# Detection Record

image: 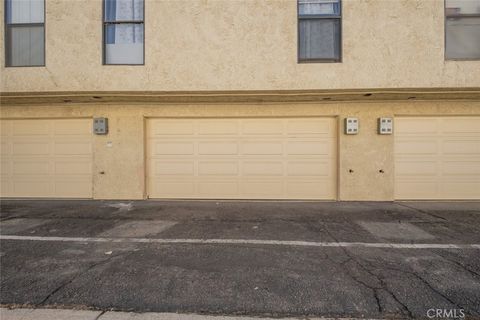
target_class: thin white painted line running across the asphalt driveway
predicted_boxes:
[0,235,480,249]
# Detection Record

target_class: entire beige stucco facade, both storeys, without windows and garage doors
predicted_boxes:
[0,0,480,201]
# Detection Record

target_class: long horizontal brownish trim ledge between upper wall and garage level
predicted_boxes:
[0,87,480,105]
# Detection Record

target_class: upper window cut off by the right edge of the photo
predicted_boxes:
[445,0,480,60]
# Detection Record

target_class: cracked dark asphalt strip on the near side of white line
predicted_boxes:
[2,241,480,317]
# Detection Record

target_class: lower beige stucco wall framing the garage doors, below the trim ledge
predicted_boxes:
[0,101,480,200]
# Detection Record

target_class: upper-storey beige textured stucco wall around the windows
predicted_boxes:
[0,0,480,92]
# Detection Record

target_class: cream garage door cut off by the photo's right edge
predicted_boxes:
[395,117,480,199]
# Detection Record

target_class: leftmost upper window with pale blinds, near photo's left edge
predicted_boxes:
[5,0,45,67]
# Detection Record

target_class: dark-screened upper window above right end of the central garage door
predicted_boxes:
[298,0,341,62]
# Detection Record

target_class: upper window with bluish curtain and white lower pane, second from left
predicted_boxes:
[103,0,144,64]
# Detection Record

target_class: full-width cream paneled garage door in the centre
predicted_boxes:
[147,118,336,199]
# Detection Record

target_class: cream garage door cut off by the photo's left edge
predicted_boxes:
[1,119,92,198]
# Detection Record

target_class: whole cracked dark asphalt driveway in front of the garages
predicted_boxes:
[0,200,480,318]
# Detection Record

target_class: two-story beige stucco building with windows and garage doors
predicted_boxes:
[0,0,480,201]
